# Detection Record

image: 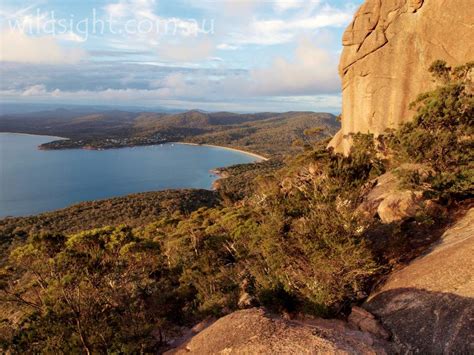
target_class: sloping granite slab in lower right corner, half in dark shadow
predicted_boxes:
[364,209,474,354]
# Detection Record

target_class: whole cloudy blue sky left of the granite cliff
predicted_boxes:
[0,0,362,112]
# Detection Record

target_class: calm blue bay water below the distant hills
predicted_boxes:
[0,133,262,218]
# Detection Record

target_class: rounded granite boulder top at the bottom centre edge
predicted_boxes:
[167,308,391,355]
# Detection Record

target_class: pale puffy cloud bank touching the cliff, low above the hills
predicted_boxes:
[141,38,340,101]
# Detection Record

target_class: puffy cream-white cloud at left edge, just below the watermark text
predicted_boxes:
[0,31,86,64]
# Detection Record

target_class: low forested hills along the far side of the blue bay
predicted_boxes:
[0,109,340,155]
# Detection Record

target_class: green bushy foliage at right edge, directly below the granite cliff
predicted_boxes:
[385,61,474,198]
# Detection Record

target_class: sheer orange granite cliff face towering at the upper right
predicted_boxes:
[330,0,474,153]
